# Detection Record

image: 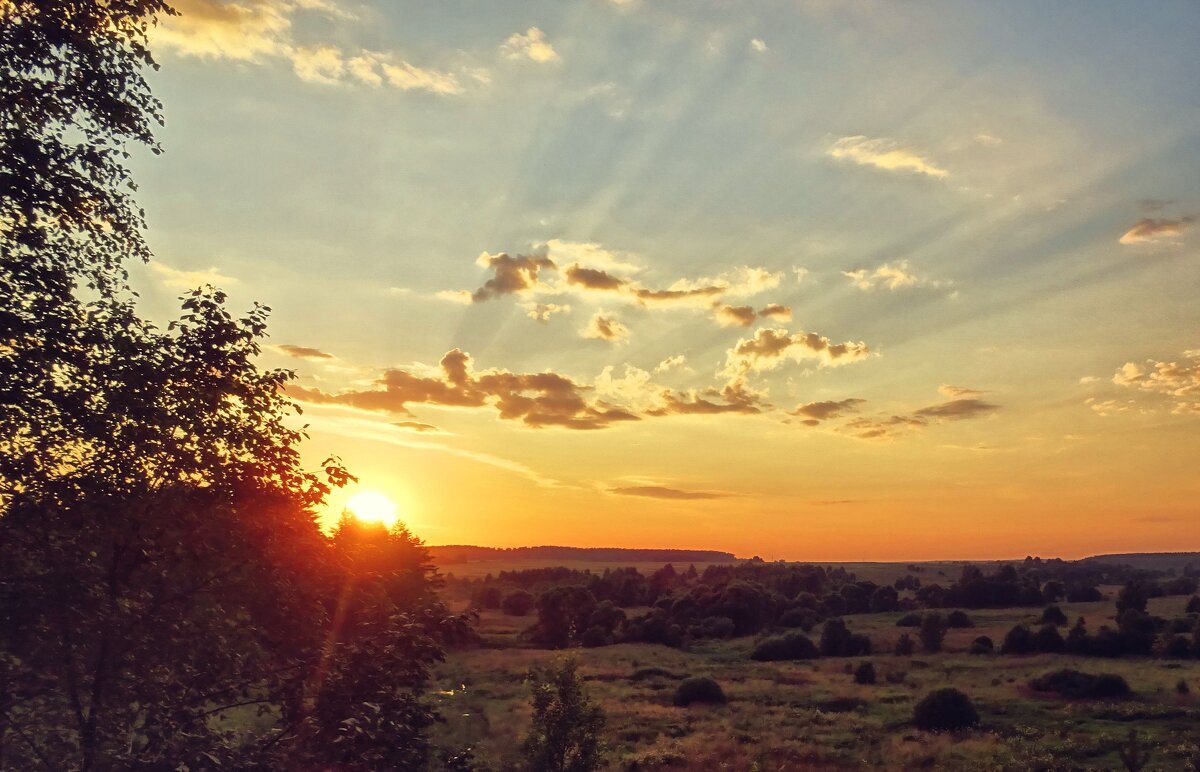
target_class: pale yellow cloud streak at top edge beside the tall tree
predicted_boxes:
[152,0,464,95]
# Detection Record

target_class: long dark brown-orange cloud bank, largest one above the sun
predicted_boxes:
[287,348,638,430]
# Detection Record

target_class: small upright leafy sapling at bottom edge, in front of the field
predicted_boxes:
[521,658,605,772]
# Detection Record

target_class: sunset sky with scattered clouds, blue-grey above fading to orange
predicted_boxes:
[126,0,1200,561]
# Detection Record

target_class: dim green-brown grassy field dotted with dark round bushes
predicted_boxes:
[437,598,1200,770]
